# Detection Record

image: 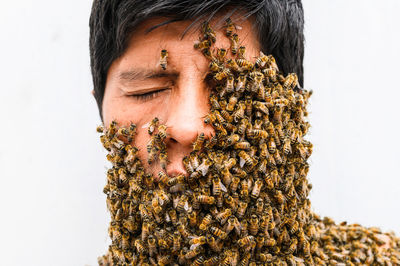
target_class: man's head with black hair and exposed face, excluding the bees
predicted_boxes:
[90,0,303,179]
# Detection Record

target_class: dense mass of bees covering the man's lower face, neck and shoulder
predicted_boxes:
[98,20,400,265]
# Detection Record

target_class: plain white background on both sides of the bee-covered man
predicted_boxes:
[0,0,400,265]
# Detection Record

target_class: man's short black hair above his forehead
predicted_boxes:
[89,0,304,118]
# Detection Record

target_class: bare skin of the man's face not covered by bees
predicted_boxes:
[103,18,260,179]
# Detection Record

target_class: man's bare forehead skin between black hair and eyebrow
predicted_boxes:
[117,15,260,64]
